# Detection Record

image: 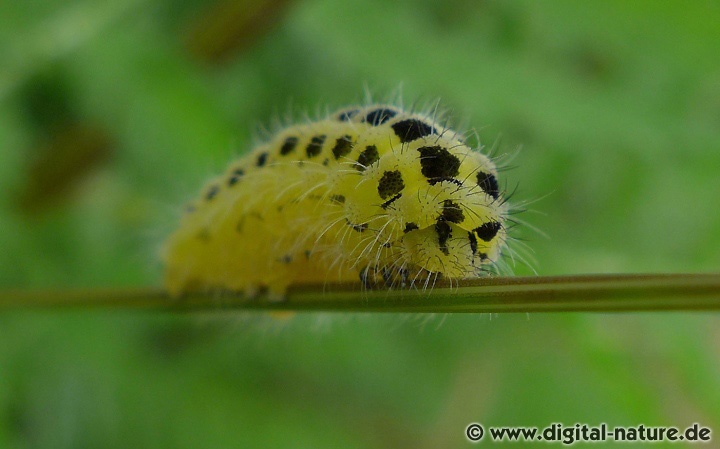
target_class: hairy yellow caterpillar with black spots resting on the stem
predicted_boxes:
[162,104,509,297]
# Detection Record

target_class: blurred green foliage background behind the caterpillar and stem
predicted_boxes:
[0,0,720,448]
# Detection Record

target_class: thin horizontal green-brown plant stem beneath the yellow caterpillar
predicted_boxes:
[0,274,720,313]
